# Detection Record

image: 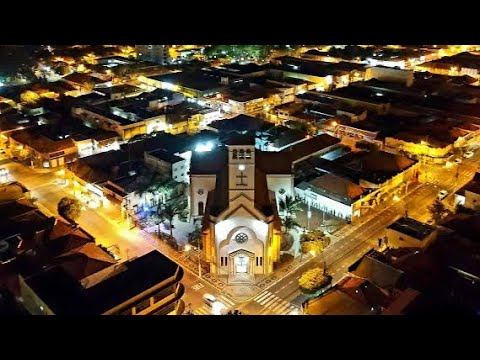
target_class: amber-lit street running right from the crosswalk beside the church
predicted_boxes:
[239,152,480,315]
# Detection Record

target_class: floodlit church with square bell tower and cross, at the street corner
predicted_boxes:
[190,135,337,282]
